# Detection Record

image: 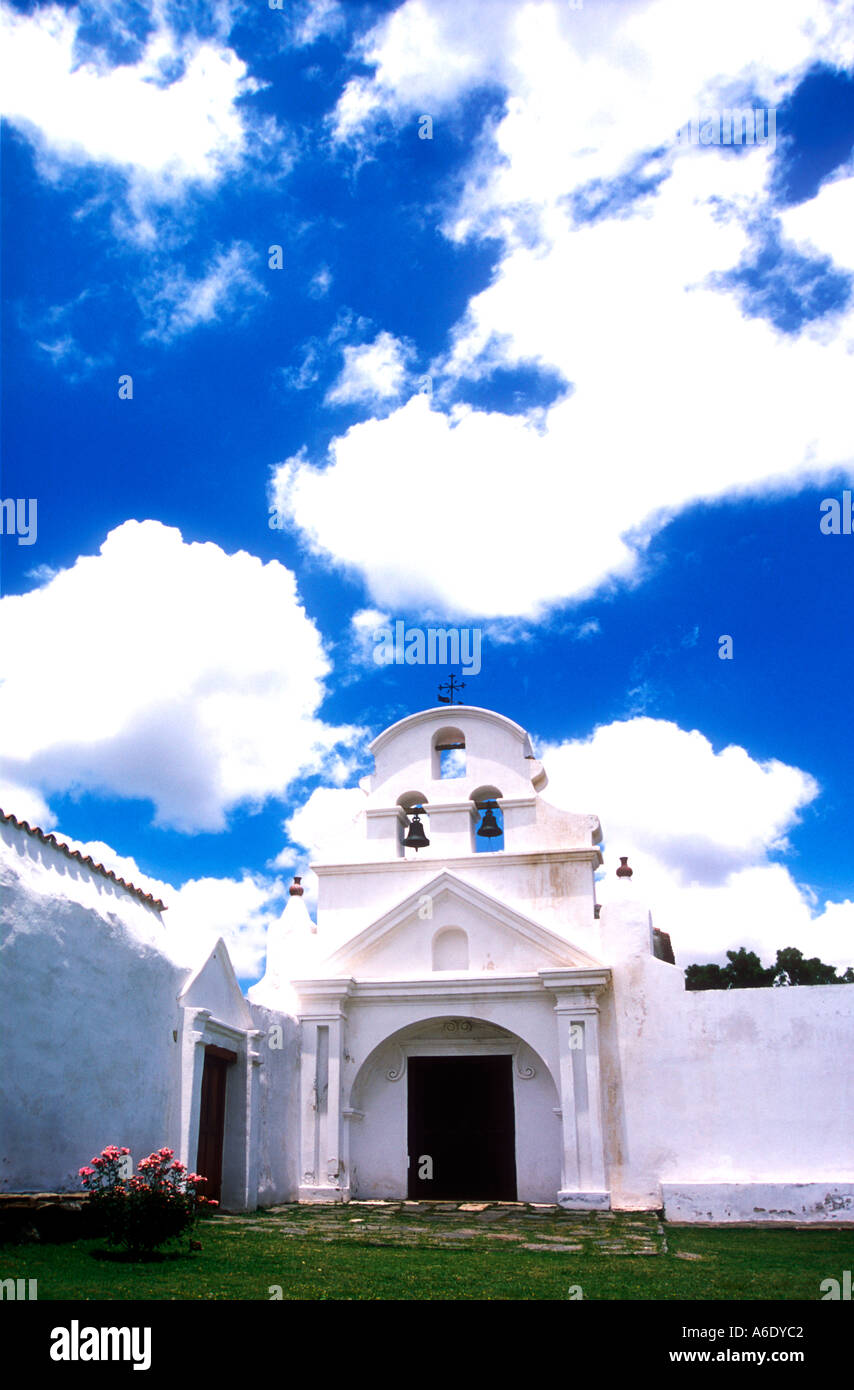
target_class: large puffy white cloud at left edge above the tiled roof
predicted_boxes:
[0,521,357,831]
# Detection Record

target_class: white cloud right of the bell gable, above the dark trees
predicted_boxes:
[541,719,854,969]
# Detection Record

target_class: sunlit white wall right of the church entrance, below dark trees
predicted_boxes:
[602,904,854,1220]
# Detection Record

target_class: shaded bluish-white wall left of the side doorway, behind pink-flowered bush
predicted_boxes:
[0,824,186,1191]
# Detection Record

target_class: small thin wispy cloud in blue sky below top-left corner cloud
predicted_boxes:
[139,242,267,342]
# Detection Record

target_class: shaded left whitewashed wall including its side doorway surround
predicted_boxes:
[0,824,299,1209]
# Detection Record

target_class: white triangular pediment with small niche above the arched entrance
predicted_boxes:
[319,869,599,980]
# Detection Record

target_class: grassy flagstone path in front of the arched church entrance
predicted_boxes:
[214,1201,668,1255]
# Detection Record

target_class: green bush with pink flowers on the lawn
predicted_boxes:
[79,1144,217,1255]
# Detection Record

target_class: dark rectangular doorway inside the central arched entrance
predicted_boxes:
[408,1056,516,1201]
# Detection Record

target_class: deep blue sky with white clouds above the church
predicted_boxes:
[0,0,854,980]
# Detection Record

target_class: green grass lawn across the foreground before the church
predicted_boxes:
[0,1218,854,1301]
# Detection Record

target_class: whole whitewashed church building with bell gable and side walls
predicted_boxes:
[0,706,854,1222]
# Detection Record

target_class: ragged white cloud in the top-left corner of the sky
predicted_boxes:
[0,3,287,247]
